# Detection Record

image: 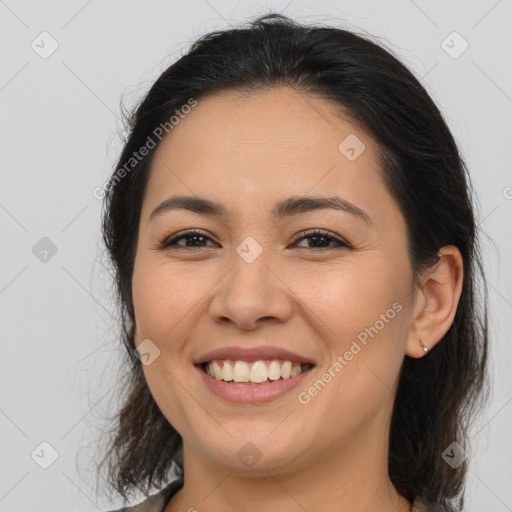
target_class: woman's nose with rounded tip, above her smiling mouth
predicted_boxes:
[210,255,293,330]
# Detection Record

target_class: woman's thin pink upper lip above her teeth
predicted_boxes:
[194,346,316,366]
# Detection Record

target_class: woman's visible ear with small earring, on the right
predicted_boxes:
[405,245,463,358]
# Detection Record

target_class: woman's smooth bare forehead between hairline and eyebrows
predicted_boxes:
[146,88,391,224]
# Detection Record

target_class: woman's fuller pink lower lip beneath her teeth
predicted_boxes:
[196,366,313,404]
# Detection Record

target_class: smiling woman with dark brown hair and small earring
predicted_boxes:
[100,15,487,512]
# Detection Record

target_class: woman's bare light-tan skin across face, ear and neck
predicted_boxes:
[133,88,462,512]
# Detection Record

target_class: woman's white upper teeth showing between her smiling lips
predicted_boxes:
[206,359,308,383]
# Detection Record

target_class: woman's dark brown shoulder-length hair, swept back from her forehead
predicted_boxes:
[99,14,488,510]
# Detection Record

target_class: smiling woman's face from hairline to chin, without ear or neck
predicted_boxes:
[132,88,412,474]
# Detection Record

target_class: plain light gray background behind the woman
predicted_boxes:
[0,0,512,512]
